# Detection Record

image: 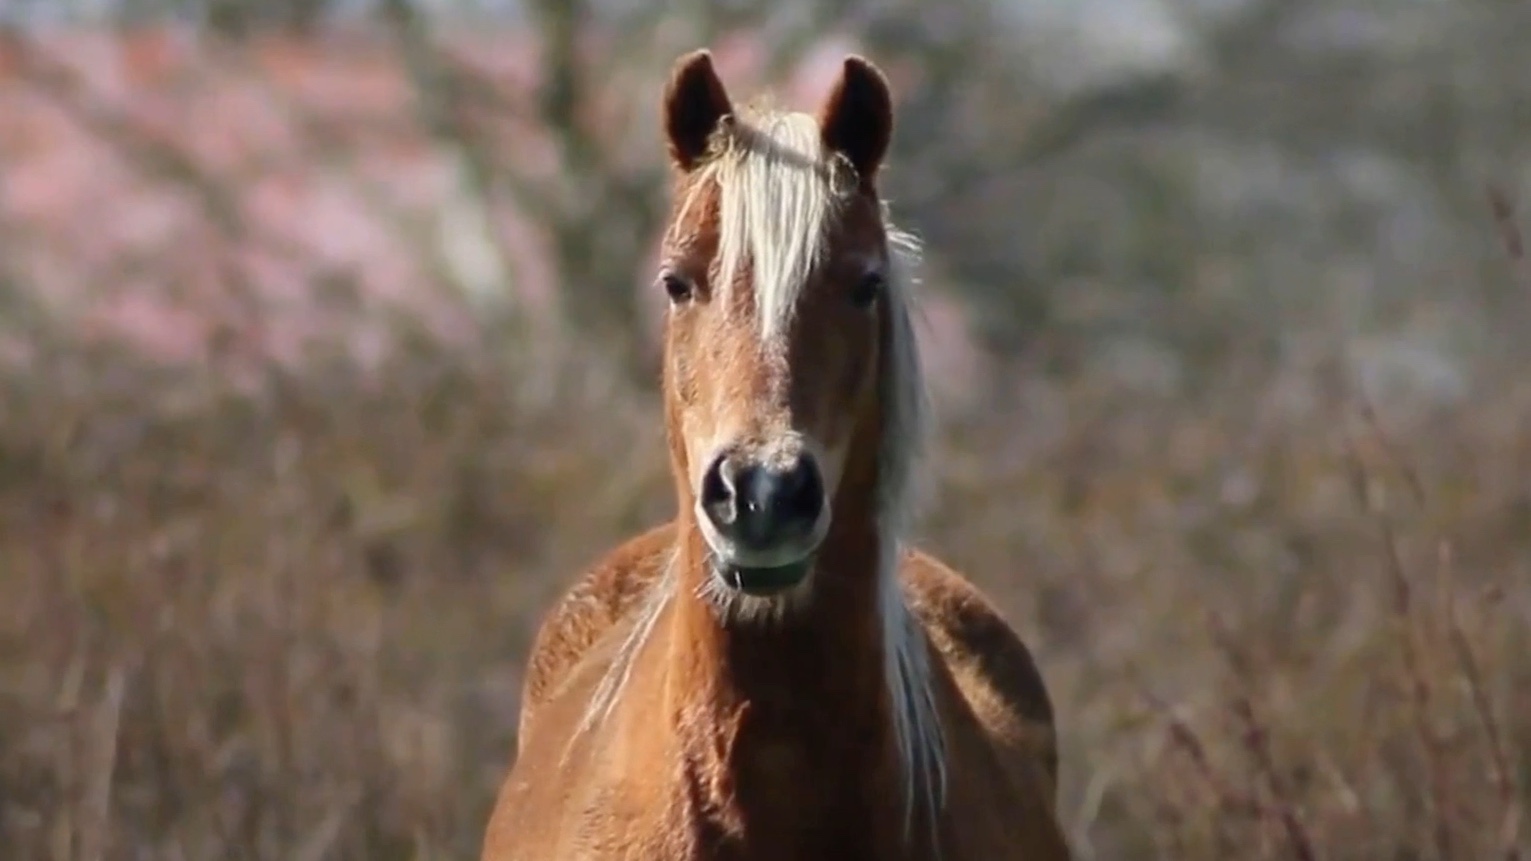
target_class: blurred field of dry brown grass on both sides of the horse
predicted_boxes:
[0,317,1531,861]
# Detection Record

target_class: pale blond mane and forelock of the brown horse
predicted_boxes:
[574,103,946,830]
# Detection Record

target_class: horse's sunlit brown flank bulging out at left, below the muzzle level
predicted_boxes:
[517,514,675,740]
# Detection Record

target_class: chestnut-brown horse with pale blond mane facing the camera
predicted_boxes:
[482,51,1069,861]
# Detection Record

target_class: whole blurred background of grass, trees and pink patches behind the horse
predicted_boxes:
[0,0,1531,861]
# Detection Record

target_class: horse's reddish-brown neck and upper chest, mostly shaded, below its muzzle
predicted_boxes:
[666,464,903,850]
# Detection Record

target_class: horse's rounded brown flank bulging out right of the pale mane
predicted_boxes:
[900,550,1058,794]
